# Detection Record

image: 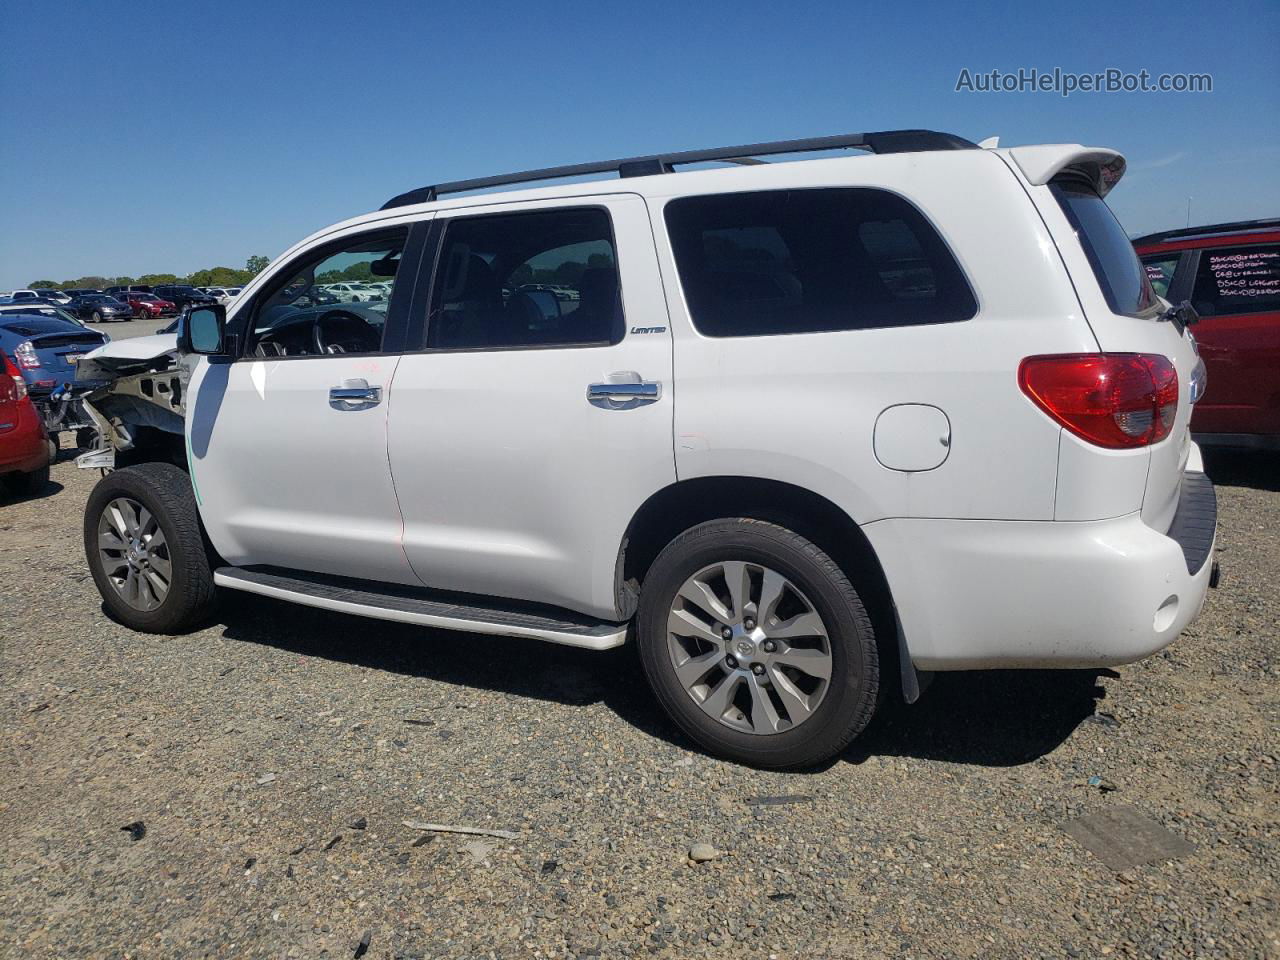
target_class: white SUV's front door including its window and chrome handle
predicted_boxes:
[187,224,426,584]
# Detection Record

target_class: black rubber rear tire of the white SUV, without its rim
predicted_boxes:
[637,518,879,769]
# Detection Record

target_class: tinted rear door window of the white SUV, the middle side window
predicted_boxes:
[426,207,623,349]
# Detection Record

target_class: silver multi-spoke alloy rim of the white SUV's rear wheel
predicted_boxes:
[667,561,832,736]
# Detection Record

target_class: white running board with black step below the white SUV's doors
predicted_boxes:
[214,567,627,650]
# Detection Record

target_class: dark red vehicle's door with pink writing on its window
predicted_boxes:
[1190,242,1280,435]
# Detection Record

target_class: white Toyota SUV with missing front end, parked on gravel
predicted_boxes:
[74,131,1216,768]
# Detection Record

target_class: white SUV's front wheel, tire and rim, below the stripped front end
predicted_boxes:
[84,463,215,634]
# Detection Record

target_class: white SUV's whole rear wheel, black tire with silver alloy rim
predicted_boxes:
[637,518,879,769]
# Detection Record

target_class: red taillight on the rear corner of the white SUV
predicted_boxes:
[1018,353,1178,449]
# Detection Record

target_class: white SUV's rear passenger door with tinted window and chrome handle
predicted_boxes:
[390,195,676,618]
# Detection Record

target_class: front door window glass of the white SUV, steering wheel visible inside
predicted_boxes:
[246,229,408,358]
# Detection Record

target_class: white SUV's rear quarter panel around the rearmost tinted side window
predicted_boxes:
[649,150,1097,524]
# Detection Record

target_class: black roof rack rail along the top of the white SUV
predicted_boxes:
[381,131,978,210]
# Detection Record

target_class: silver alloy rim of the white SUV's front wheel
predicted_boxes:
[97,497,173,611]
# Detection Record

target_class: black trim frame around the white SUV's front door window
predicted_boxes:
[228,219,431,364]
